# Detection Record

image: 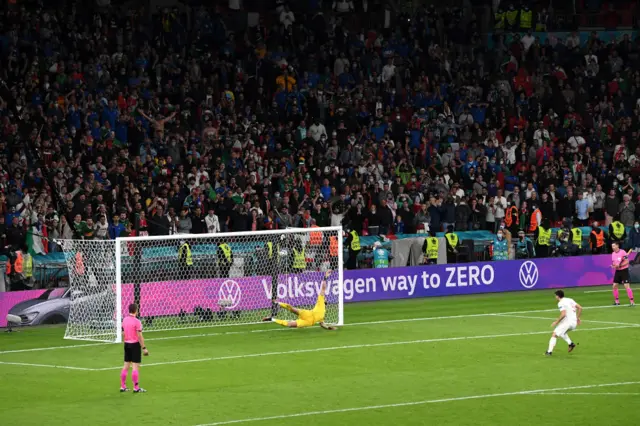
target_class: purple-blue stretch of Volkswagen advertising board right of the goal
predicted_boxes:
[344,255,613,302]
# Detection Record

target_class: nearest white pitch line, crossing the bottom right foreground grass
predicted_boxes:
[198,382,640,426]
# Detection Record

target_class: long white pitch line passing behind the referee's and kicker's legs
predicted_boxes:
[93,325,637,371]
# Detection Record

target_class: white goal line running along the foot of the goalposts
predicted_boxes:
[0,305,614,355]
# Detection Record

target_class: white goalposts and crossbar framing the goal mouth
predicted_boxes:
[102,226,344,343]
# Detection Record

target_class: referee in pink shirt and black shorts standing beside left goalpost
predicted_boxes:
[120,303,149,393]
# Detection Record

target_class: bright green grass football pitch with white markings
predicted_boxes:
[0,286,640,426]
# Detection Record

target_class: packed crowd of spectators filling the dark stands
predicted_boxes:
[0,0,640,272]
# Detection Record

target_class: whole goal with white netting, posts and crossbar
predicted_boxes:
[62,227,344,342]
